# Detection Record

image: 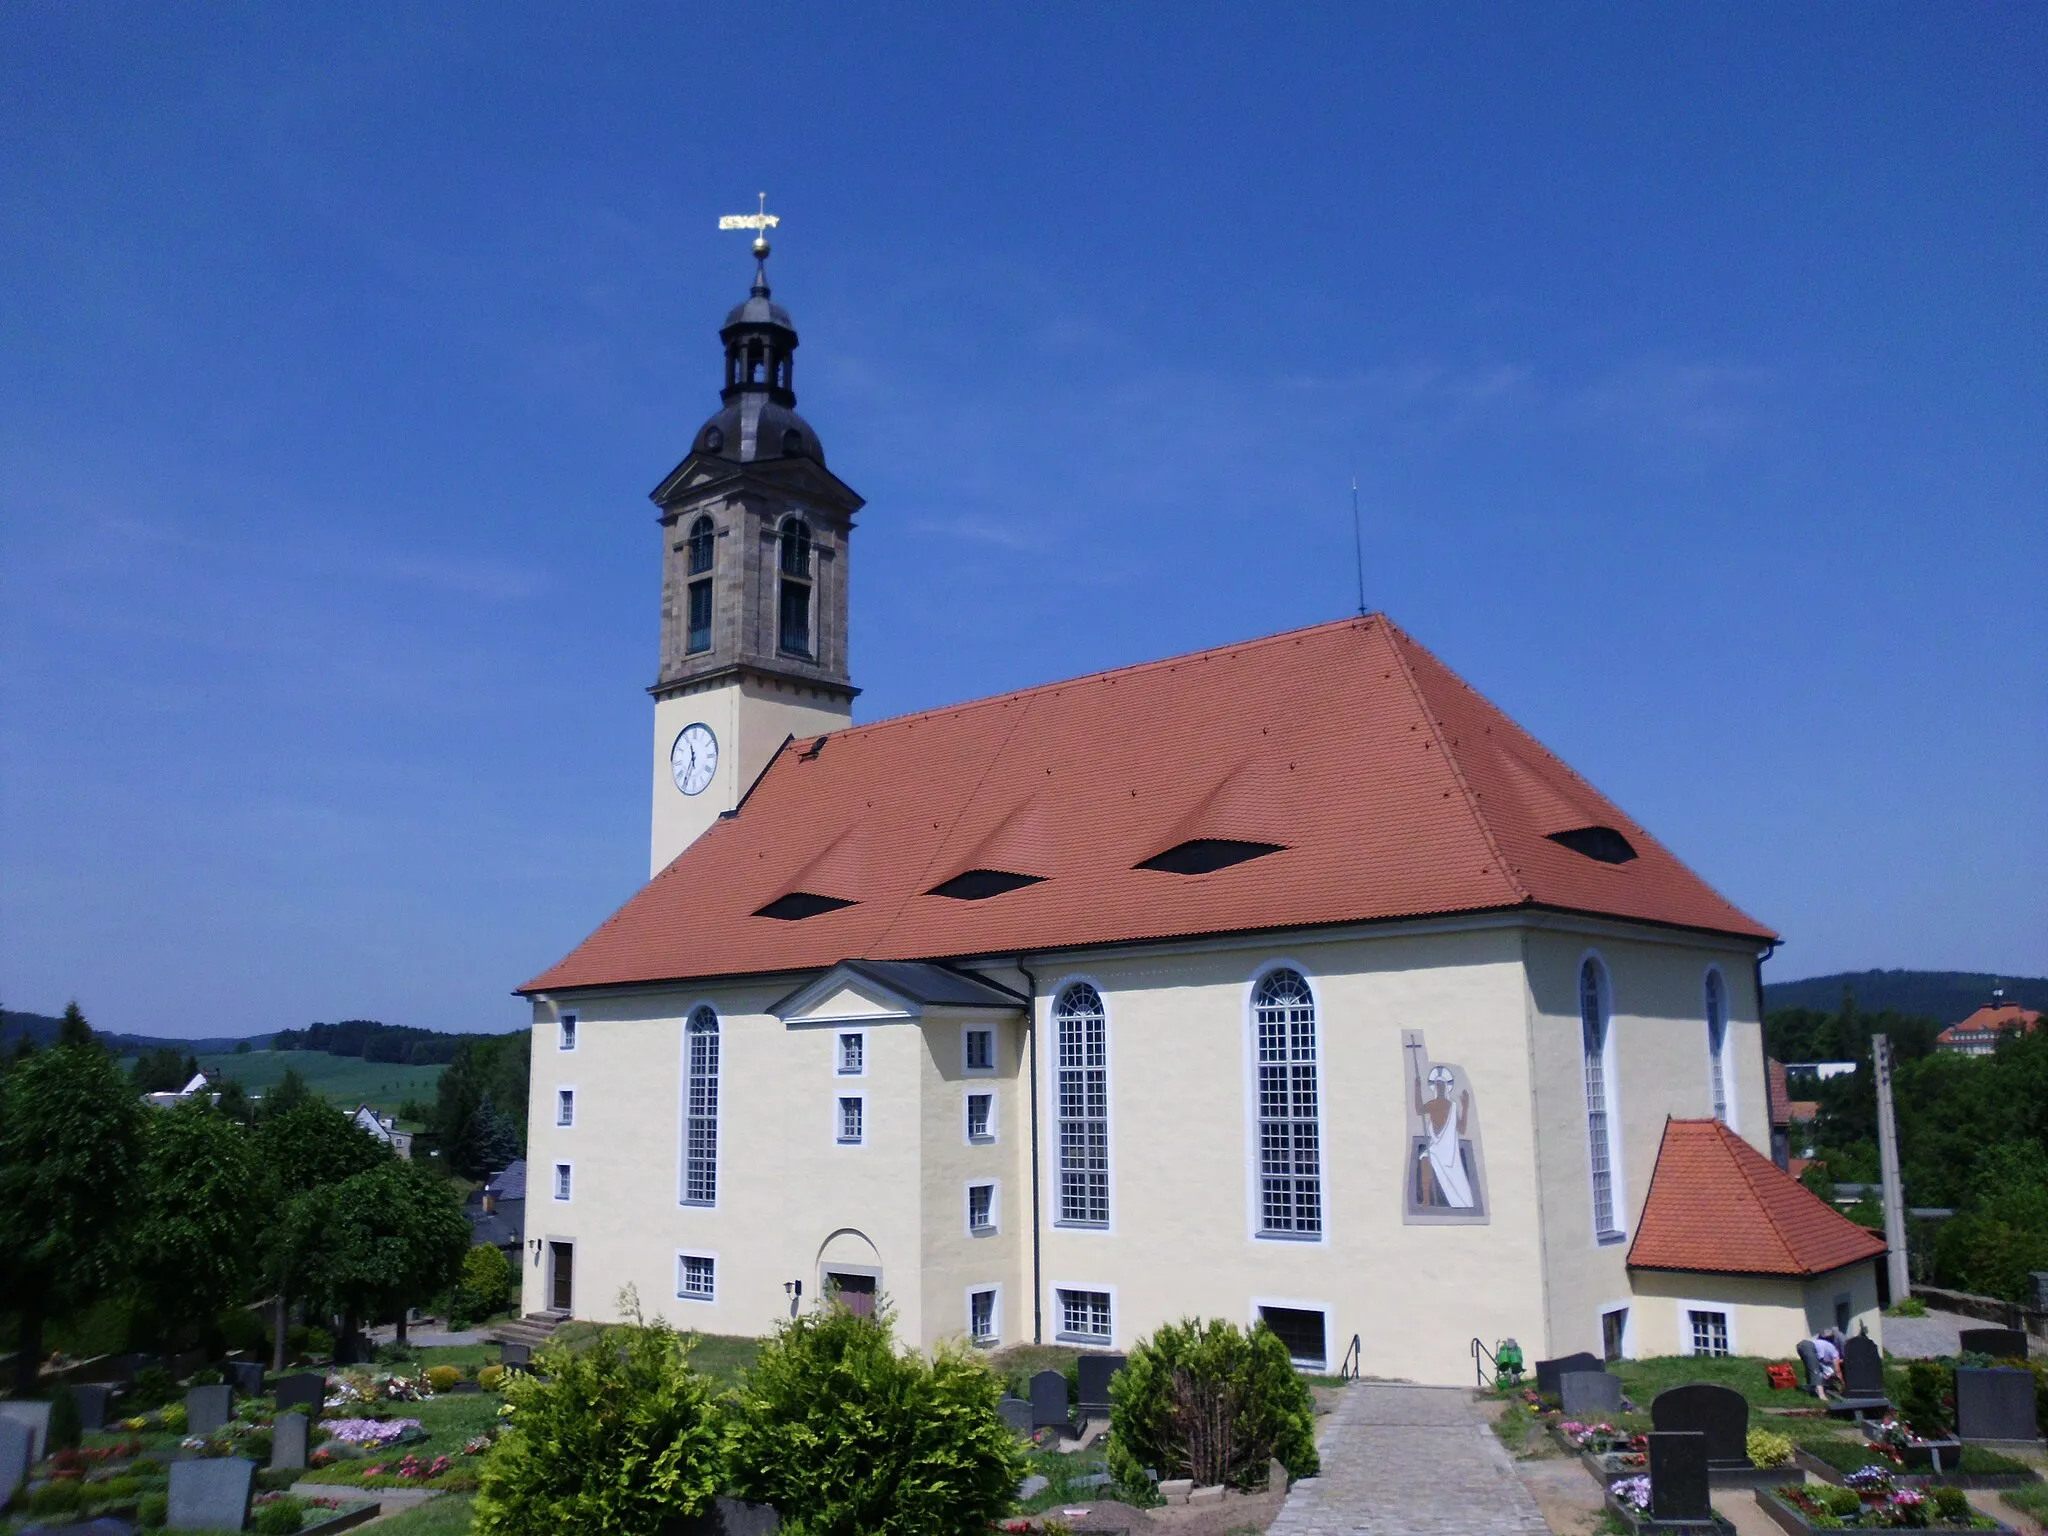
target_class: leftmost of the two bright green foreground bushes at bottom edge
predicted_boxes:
[475,1323,725,1536]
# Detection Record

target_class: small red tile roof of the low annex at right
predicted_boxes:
[1628,1120,1884,1276]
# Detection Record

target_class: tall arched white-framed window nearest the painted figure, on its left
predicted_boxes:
[1251,971,1323,1237]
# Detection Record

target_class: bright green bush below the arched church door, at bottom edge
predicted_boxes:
[729,1303,1024,1536]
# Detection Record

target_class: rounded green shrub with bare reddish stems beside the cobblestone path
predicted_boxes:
[1110,1319,1319,1491]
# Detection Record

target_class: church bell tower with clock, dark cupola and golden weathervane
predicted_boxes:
[647,211,862,877]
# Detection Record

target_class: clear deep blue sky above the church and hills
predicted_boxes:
[0,0,2048,1034]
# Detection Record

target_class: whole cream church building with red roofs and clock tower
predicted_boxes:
[520,240,1882,1382]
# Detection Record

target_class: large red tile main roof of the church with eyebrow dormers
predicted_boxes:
[522,614,1774,991]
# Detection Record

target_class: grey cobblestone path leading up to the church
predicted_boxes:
[1268,1382,1550,1536]
